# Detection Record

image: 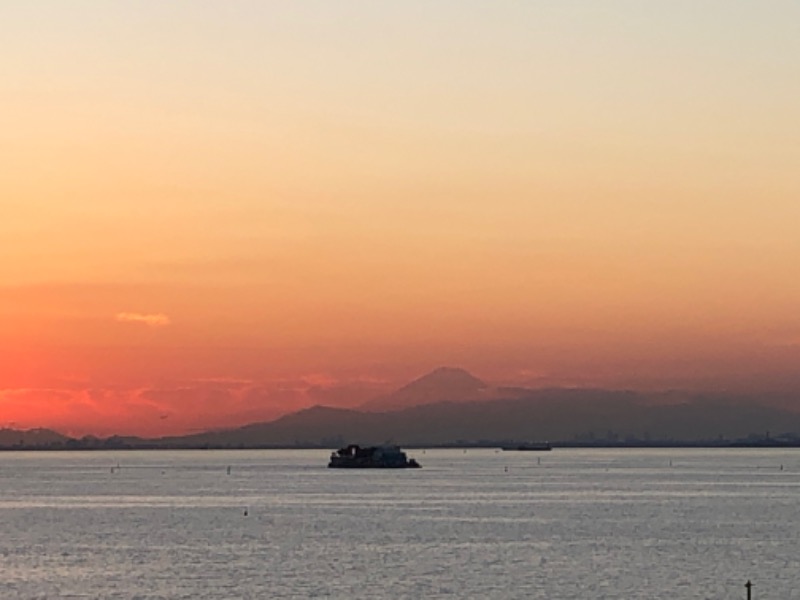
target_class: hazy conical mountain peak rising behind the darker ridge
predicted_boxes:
[359,367,493,412]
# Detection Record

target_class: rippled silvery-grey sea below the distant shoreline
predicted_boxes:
[0,448,800,600]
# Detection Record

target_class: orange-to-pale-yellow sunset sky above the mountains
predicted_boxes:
[0,0,800,435]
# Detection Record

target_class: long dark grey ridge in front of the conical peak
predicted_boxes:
[161,389,800,447]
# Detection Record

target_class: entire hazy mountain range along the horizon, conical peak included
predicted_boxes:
[6,368,800,449]
